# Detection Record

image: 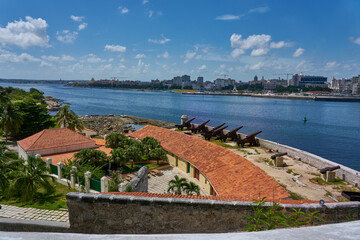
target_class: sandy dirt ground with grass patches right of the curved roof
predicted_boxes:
[190,135,360,202]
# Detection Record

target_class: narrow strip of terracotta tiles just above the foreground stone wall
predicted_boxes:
[104,192,317,204]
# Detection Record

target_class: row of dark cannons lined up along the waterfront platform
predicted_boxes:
[176,115,262,147]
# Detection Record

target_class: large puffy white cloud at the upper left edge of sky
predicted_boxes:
[0,16,50,48]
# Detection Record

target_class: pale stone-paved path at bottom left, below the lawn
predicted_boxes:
[0,204,69,222]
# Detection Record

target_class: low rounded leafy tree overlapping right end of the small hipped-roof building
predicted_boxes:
[74,148,108,167]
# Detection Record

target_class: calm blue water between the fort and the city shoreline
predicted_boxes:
[0,82,360,170]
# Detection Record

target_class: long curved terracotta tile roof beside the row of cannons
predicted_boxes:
[128,125,290,201]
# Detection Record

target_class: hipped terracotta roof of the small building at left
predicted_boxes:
[17,128,94,151]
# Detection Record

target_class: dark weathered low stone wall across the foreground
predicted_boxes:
[66,193,360,234]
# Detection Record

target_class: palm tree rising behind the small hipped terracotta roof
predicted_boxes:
[55,104,84,131]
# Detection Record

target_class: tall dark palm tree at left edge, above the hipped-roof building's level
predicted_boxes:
[0,99,23,142]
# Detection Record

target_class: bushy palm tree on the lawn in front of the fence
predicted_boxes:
[9,157,54,201]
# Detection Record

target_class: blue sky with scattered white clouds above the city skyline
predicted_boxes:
[0,0,360,81]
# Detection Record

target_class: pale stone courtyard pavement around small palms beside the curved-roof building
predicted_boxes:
[148,167,208,196]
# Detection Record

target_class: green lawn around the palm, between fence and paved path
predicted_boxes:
[0,182,75,210]
